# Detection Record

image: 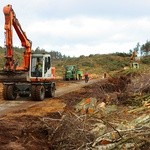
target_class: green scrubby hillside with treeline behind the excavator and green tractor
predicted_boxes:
[0,47,150,76]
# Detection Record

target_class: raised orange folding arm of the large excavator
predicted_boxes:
[3,5,32,71]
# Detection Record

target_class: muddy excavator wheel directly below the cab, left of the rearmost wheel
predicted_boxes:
[36,85,45,101]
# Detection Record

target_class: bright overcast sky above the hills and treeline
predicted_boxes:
[0,0,150,56]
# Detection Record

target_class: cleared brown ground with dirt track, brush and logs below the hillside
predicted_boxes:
[0,74,150,150]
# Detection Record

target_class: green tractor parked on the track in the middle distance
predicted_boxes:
[64,65,83,80]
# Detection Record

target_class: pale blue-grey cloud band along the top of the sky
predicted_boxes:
[28,0,150,18]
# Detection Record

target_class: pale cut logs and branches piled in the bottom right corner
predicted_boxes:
[92,114,150,150]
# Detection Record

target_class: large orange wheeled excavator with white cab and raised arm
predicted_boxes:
[0,4,56,101]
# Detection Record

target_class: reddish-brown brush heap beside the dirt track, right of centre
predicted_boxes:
[83,76,131,104]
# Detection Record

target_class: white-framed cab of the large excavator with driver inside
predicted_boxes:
[29,54,55,80]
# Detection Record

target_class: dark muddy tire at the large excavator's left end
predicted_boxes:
[7,85,17,100]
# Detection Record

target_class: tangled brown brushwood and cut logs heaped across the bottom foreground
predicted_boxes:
[20,112,150,150]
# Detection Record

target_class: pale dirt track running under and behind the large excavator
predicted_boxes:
[0,79,100,117]
